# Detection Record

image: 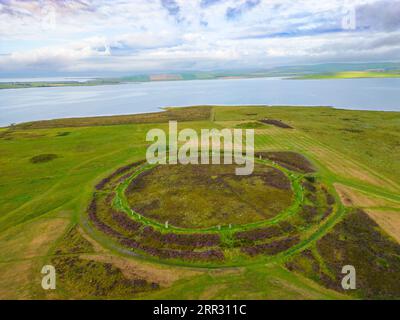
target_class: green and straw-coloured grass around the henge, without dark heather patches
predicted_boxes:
[0,106,400,299]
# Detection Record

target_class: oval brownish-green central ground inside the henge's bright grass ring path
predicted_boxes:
[126,164,293,228]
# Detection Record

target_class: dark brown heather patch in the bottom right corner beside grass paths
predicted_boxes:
[286,210,400,299]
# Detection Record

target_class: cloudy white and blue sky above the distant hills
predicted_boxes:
[0,0,400,77]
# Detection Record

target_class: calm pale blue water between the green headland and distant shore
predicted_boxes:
[0,77,400,127]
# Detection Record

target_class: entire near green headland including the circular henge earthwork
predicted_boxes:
[0,106,400,299]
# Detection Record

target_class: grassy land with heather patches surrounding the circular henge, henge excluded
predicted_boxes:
[0,106,400,299]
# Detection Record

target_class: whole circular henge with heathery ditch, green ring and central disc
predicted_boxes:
[88,156,336,267]
